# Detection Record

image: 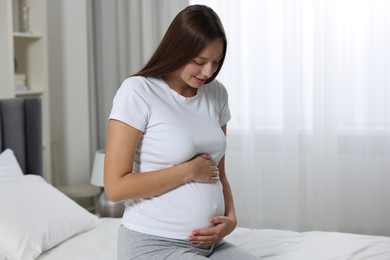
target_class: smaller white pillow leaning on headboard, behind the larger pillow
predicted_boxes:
[0,149,23,181]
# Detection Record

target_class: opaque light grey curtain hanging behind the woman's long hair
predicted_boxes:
[89,0,188,150]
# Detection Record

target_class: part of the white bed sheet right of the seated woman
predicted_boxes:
[226,228,390,260]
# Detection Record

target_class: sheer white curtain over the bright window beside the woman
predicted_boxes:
[190,0,390,235]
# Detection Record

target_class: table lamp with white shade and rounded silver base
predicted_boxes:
[91,150,125,218]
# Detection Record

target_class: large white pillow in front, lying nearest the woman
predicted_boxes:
[0,175,100,260]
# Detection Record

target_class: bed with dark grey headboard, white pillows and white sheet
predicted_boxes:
[0,99,390,260]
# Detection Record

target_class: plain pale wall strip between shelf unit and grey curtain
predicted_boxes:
[47,0,91,185]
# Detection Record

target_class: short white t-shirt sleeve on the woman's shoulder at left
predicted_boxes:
[109,77,150,132]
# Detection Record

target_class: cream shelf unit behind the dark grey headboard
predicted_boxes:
[0,0,51,181]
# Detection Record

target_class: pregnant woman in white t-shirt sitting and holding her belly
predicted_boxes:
[104,5,257,260]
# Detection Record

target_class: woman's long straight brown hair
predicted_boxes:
[134,5,227,83]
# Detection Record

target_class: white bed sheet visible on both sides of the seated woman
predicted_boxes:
[38,218,390,260]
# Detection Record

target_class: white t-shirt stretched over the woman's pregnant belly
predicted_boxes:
[110,76,230,239]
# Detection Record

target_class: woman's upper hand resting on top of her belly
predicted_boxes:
[188,154,219,182]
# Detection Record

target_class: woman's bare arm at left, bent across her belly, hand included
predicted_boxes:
[104,119,218,201]
